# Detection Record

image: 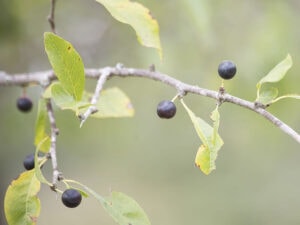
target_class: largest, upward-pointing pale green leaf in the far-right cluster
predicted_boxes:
[256,54,293,95]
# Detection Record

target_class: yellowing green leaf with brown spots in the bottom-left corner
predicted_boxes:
[4,170,40,225]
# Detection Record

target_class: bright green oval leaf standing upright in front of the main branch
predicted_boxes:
[44,32,85,101]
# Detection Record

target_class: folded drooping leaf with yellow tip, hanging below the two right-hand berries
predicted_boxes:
[180,99,224,175]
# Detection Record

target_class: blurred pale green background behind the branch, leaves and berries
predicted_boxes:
[0,0,300,225]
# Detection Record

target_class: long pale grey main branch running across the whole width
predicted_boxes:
[0,66,300,143]
